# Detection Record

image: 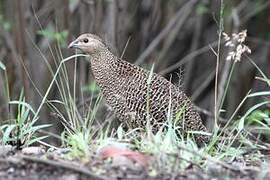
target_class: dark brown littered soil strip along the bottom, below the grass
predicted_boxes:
[0,146,270,180]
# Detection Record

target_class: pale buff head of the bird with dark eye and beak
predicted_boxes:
[68,34,107,54]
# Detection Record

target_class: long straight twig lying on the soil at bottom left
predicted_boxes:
[20,155,108,180]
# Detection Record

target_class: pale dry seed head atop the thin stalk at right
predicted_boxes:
[222,30,251,62]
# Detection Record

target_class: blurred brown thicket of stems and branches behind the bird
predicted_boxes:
[0,0,270,136]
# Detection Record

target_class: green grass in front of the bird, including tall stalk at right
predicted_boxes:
[0,1,270,179]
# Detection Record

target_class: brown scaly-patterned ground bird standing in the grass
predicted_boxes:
[68,33,209,143]
